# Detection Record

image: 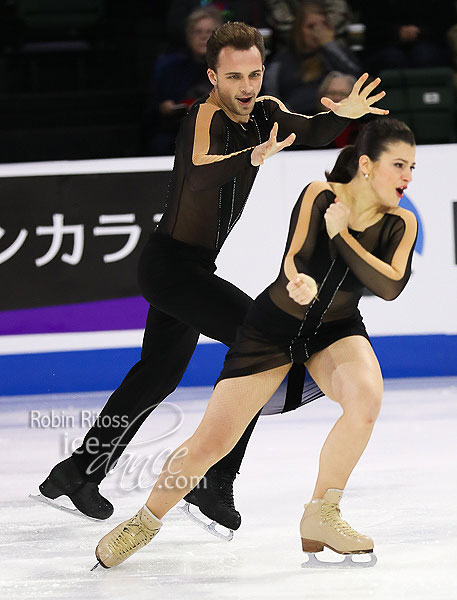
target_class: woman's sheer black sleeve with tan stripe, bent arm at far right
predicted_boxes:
[333,208,417,300]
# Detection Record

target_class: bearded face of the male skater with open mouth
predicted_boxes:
[208,46,264,122]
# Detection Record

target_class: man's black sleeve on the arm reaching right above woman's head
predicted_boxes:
[259,96,351,148]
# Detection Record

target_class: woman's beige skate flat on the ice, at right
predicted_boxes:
[300,489,377,568]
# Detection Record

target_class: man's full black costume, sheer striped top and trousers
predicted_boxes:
[68,92,348,482]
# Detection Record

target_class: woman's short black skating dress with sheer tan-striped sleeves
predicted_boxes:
[218,182,417,398]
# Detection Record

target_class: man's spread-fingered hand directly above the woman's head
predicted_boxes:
[321,73,389,119]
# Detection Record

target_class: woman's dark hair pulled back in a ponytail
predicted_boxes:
[325,117,416,183]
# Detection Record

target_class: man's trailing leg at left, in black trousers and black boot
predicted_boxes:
[40,307,199,519]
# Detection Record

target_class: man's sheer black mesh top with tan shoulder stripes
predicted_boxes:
[157,92,348,253]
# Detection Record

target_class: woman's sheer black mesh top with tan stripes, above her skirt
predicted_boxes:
[268,181,417,321]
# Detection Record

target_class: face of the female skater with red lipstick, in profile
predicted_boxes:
[368,142,416,208]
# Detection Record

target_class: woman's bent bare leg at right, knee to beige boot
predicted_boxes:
[306,336,383,499]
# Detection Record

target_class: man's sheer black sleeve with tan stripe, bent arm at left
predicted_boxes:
[182,103,258,192]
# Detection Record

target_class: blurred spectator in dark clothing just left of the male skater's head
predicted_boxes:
[146,7,222,156]
